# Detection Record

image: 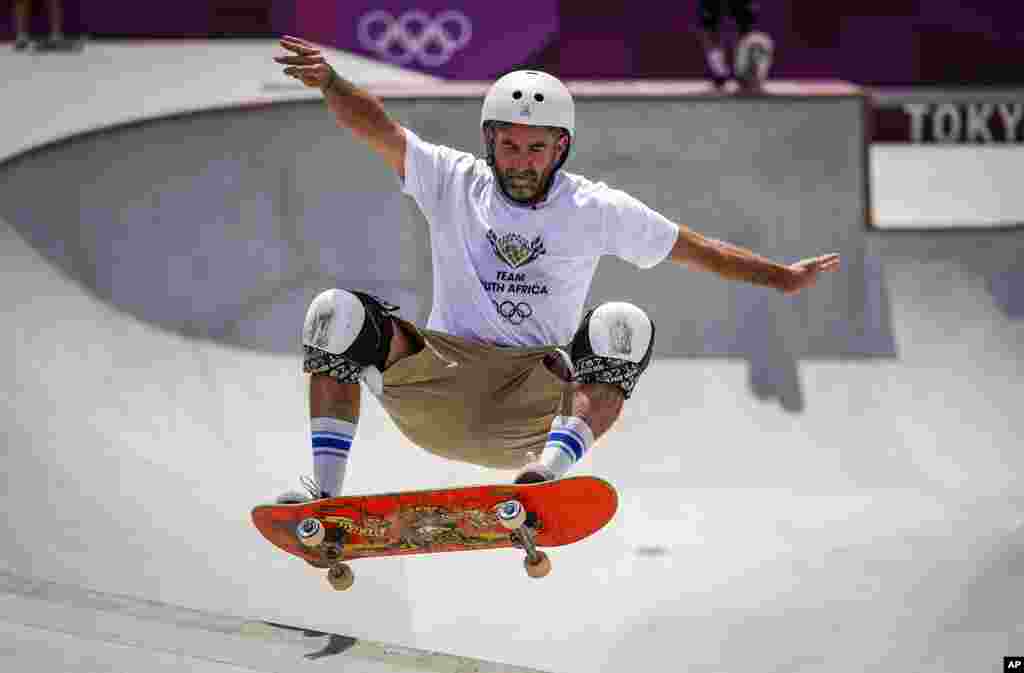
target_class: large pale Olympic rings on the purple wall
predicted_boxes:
[358,9,473,68]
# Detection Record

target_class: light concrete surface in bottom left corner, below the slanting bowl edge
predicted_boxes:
[0,574,540,673]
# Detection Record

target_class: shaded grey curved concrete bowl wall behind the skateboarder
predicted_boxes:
[0,87,896,395]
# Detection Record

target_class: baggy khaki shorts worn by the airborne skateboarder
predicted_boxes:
[380,316,571,469]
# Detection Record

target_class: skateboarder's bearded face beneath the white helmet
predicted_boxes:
[494,124,568,203]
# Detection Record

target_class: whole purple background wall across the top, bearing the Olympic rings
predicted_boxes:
[0,0,1024,86]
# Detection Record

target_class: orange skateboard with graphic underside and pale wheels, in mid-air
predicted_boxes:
[252,476,618,590]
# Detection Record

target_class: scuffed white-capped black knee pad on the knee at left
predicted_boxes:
[302,290,398,383]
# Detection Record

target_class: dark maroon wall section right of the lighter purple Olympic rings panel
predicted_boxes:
[520,0,1024,85]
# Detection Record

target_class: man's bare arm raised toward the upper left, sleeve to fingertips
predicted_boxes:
[274,35,406,177]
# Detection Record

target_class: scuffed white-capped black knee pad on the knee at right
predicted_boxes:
[569,302,654,399]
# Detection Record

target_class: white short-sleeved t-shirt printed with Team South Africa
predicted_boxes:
[402,129,679,346]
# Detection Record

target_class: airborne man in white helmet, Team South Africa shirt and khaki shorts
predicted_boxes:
[274,37,839,502]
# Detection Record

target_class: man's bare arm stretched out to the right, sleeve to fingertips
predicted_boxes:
[669,224,840,294]
